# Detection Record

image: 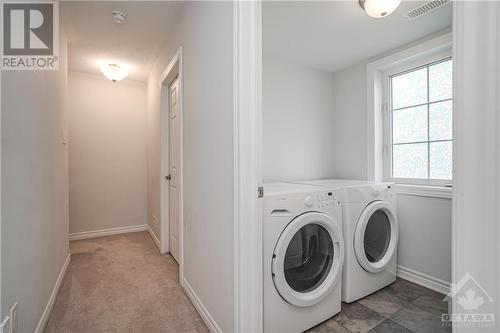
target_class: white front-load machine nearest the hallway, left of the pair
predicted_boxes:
[263,183,344,333]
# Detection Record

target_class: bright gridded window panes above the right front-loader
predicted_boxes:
[385,58,453,185]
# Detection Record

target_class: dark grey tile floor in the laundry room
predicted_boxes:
[308,279,451,333]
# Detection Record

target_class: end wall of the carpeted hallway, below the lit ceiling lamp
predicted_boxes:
[69,71,147,233]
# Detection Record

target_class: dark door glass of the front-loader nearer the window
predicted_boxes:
[363,209,391,262]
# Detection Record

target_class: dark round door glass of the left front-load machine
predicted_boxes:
[284,223,334,293]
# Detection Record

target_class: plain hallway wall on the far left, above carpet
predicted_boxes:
[1,33,69,333]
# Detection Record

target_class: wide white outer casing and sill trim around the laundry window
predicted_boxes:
[366,32,452,198]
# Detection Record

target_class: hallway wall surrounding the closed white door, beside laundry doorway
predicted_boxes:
[148,2,234,332]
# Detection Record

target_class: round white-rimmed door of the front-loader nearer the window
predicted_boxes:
[354,201,399,273]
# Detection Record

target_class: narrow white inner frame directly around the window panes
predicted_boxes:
[382,49,453,187]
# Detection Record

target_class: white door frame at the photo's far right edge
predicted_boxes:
[450,1,500,322]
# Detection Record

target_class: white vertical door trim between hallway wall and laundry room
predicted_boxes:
[233,0,264,332]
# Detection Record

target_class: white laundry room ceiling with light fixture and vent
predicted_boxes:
[262,0,452,72]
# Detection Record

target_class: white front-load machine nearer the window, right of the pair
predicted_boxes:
[290,179,399,303]
